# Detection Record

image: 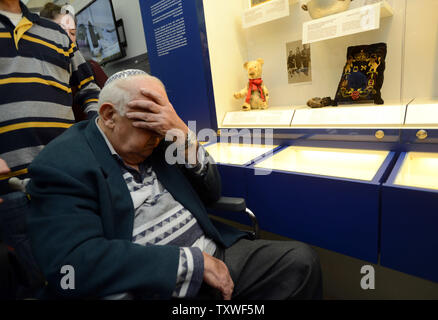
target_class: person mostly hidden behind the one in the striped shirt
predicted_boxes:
[40,2,108,121]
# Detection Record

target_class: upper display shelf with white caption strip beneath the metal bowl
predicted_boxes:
[303,1,394,43]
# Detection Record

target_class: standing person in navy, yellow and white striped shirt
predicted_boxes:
[0,0,100,298]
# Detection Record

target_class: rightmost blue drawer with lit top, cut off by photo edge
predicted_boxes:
[381,151,438,282]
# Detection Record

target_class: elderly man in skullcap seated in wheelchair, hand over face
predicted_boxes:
[28,70,321,299]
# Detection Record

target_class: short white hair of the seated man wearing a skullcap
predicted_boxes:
[98,69,165,116]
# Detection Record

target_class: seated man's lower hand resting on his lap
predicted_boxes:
[202,252,234,300]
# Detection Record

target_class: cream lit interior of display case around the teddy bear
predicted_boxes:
[204,0,408,134]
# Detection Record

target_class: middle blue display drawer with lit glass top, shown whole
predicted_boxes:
[246,146,395,263]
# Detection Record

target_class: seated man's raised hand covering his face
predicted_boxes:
[126,89,188,137]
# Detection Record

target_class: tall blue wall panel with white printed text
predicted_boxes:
[140,0,217,131]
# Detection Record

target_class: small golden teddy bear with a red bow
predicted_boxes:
[234,58,269,111]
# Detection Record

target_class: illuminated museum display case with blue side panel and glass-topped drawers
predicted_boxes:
[140,0,438,281]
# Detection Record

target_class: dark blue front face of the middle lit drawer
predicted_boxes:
[247,170,380,263]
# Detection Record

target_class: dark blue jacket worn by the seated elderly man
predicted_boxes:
[28,119,245,299]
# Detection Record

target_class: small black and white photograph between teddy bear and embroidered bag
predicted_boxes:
[286,40,312,83]
